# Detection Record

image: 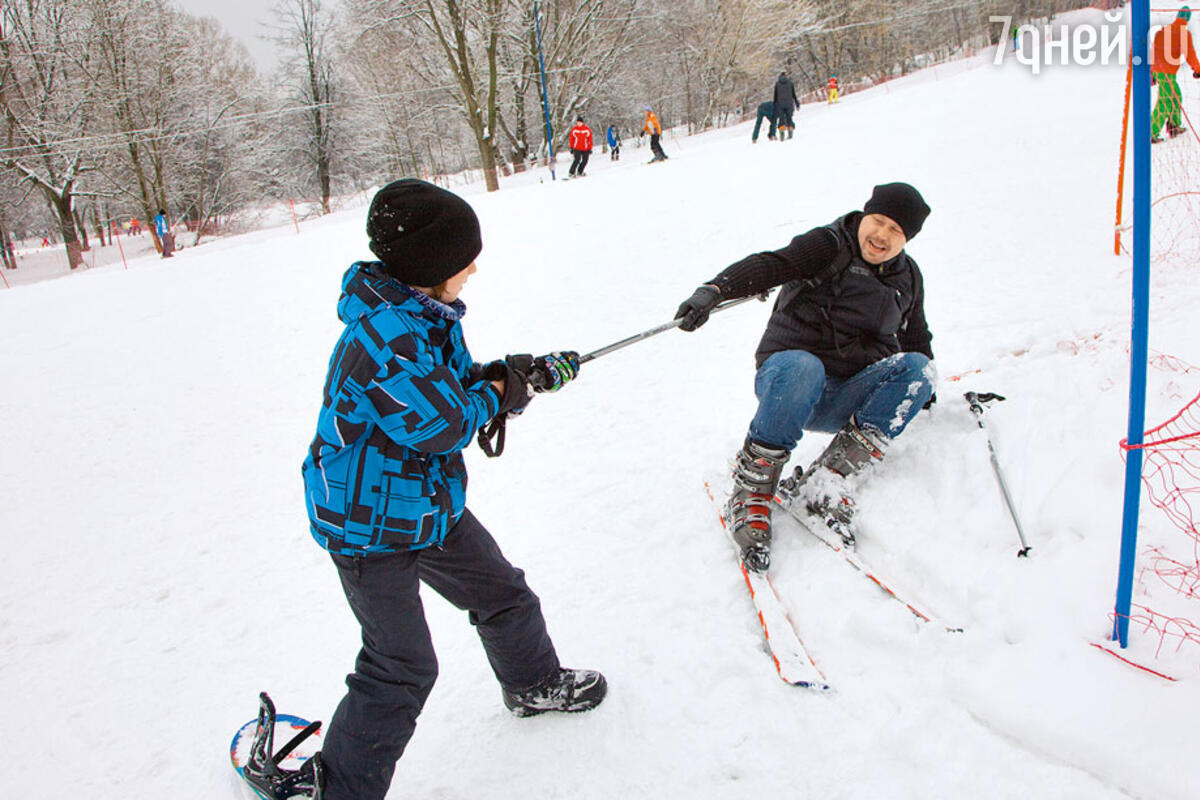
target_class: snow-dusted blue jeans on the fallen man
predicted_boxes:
[750,350,934,451]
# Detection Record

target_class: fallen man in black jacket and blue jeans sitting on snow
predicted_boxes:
[676,184,936,571]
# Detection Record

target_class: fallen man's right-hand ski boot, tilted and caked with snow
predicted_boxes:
[779,417,890,548]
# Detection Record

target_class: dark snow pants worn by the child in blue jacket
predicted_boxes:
[322,510,559,800]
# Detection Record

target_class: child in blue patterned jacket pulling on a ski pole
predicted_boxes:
[301,179,606,800]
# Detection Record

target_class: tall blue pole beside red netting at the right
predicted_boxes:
[1112,0,1150,648]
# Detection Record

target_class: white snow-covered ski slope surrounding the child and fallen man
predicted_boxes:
[0,31,1200,800]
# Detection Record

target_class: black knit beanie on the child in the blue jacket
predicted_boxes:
[367,178,484,287]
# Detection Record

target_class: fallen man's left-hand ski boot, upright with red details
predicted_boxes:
[725,439,791,572]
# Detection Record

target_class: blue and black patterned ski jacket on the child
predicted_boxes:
[302,261,500,555]
